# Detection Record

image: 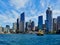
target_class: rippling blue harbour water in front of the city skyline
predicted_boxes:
[0,34,60,45]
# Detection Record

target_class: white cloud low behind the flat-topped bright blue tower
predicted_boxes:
[26,12,46,25]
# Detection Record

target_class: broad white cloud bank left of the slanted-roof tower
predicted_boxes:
[0,10,19,23]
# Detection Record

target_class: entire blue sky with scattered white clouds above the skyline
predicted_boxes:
[0,0,60,27]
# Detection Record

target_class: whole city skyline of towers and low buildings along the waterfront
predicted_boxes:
[0,7,60,34]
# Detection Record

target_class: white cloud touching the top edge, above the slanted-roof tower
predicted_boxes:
[10,0,29,9]
